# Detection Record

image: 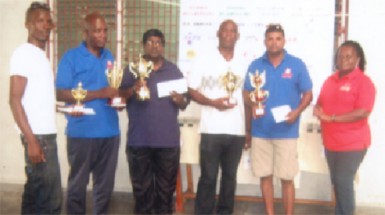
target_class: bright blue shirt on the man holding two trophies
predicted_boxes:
[56,42,120,138]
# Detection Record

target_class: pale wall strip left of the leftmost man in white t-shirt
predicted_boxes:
[0,0,34,183]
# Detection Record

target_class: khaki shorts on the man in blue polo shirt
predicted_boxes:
[251,137,299,180]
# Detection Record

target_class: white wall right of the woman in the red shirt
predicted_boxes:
[348,0,385,207]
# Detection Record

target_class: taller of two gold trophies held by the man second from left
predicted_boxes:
[106,61,126,107]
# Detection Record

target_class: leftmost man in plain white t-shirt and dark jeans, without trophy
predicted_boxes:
[9,2,62,214]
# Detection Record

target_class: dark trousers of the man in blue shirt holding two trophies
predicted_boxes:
[67,136,120,214]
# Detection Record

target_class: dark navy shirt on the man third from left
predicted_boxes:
[122,60,183,148]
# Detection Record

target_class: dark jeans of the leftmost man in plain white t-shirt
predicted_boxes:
[21,134,62,214]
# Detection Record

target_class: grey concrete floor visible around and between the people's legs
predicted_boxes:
[0,184,385,215]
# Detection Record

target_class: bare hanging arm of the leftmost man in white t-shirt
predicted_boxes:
[9,75,45,163]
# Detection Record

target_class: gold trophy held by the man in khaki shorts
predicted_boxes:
[249,70,269,116]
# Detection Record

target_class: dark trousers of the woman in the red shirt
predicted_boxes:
[325,149,366,215]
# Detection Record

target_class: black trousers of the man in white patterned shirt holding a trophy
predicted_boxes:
[195,134,245,214]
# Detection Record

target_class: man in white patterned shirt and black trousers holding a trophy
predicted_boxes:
[189,20,247,214]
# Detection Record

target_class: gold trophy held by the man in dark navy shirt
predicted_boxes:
[129,54,154,101]
